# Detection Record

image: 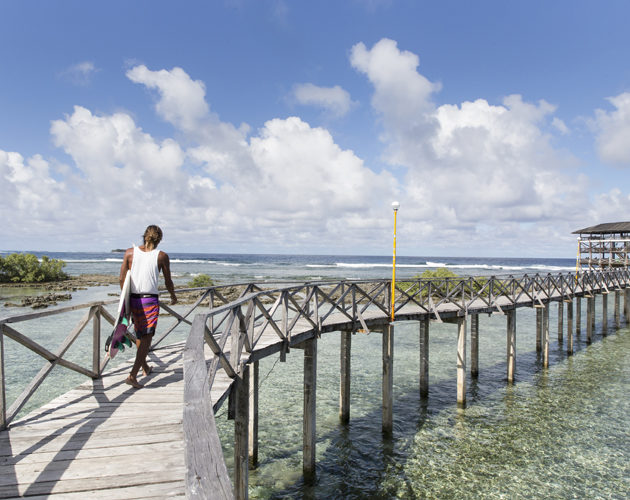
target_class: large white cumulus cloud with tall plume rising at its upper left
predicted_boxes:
[350,39,588,252]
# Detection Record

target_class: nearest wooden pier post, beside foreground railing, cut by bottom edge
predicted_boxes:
[234,365,249,500]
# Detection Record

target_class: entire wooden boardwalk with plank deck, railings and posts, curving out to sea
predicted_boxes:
[0,272,630,499]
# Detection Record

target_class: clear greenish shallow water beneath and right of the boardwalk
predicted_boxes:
[217,309,630,499]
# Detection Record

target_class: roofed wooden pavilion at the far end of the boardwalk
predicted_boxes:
[573,222,630,270]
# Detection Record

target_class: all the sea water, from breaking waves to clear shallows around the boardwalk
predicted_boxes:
[0,252,630,499]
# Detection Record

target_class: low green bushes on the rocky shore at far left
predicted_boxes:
[0,253,68,283]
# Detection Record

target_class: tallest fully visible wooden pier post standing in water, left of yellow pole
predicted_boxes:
[302,337,317,482]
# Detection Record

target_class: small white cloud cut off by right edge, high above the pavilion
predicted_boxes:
[595,92,630,167]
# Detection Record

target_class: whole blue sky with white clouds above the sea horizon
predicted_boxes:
[0,0,630,257]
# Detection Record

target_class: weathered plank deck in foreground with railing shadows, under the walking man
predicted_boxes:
[0,344,205,499]
